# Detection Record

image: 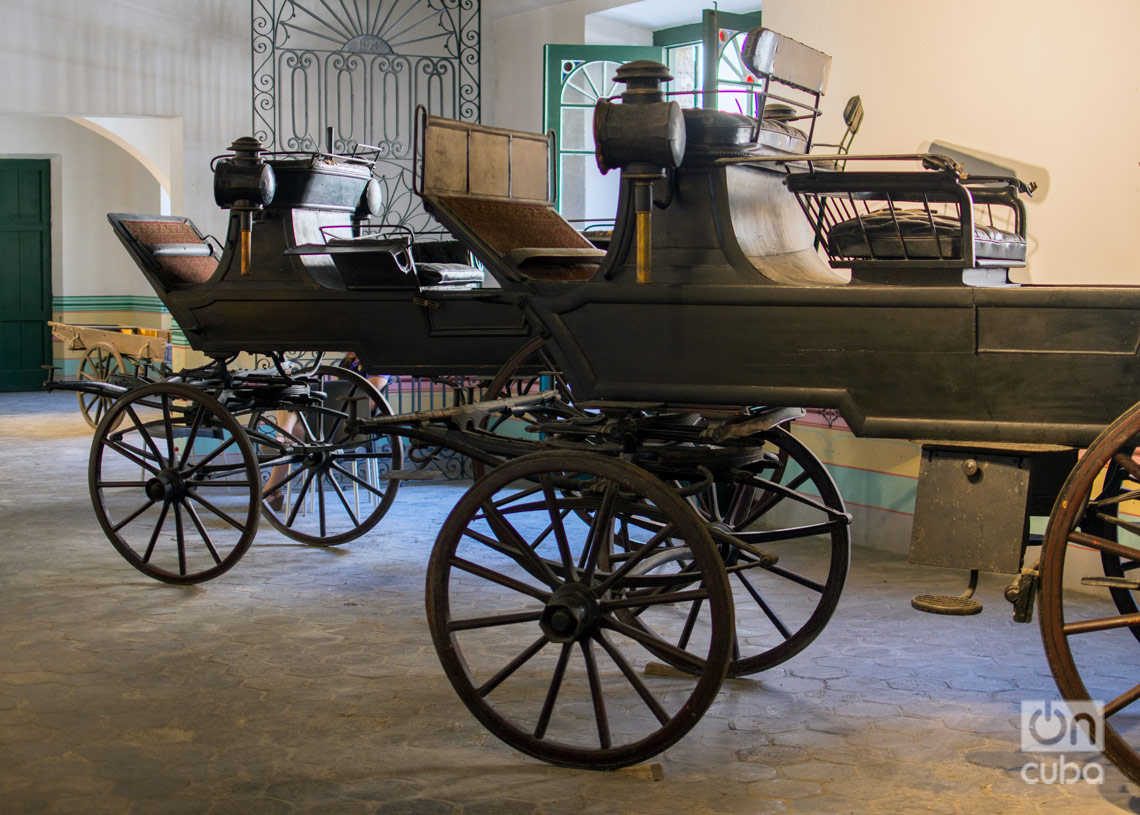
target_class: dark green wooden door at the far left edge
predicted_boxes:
[0,158,51,391]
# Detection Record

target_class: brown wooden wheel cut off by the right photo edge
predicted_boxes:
[1040,405,1140,783]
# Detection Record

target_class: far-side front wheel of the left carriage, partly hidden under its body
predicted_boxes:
[246,365,404,546]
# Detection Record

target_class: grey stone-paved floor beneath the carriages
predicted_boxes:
[0,394,1140,815]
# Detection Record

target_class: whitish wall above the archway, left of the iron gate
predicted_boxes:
[0,0,251,237]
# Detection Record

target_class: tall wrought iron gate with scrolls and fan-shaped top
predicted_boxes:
[251,0,480,231]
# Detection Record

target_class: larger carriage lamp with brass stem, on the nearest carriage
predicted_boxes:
[594,59,685,283]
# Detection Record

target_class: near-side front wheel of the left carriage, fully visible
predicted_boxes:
[88,382,260,584]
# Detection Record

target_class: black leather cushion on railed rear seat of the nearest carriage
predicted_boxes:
[828,209,1025,266]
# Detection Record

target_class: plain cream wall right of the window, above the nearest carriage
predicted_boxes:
[764,0,1140,285]
